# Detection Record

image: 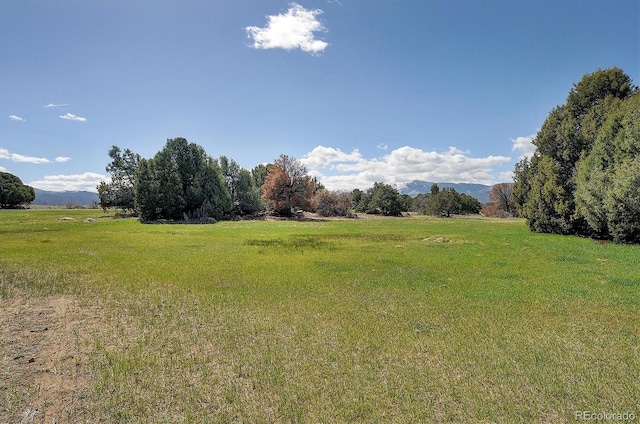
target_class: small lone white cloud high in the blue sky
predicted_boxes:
[245,3,329,55]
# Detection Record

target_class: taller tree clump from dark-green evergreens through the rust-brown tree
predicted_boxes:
[97,138,326,222]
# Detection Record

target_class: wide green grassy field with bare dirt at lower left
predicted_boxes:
[0,210,640,423]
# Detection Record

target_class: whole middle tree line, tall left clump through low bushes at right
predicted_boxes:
[97,138,482,222]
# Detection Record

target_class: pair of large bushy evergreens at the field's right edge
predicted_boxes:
[513,68,640,243]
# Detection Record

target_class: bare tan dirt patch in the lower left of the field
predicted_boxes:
[0,296,99,423]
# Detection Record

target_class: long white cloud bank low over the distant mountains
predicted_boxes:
[302,146,511,190]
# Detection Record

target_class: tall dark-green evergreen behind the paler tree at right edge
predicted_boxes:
[514,68,634,234]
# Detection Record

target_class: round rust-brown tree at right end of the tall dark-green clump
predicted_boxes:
[262,155,316,216]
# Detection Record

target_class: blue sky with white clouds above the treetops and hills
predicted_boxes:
[0,0,640,191]
